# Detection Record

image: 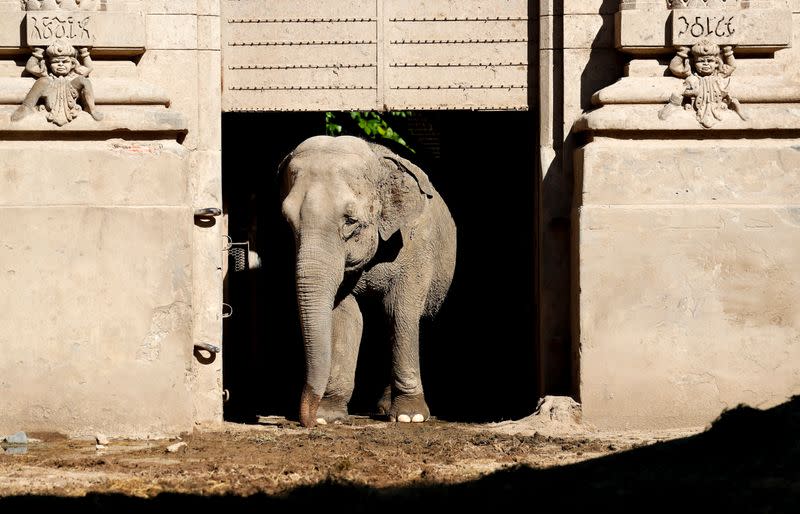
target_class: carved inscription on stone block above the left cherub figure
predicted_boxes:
[26,12,94,46]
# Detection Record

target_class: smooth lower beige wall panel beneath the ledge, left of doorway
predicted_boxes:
[0,140,192,437]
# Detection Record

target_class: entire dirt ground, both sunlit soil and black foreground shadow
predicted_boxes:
[0,397,800,513]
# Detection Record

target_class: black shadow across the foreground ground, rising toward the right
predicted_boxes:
[0,396,800,513]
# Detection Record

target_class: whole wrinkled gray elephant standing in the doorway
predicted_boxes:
[280,136,456,427]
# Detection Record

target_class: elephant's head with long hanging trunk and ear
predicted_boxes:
[280,136,433,426]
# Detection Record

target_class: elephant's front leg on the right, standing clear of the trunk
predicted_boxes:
[388,301,430,423]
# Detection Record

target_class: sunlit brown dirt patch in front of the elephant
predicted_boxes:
[0,418,680,497]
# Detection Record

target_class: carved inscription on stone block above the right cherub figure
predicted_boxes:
[672,9,740,46]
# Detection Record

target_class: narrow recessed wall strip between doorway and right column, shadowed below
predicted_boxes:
[538,0,624,394]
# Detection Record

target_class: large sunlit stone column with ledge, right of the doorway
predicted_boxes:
[573,0,800,428]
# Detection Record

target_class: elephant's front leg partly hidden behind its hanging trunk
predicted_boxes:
[317,295,364,425]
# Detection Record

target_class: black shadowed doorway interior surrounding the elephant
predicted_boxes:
[222,111,538,422]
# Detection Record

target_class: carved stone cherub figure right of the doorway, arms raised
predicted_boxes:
[658,40,747,128]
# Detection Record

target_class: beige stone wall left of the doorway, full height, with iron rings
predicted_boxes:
[0,0,223,437]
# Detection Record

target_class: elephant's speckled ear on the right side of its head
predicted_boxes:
[378,149,434,241]
